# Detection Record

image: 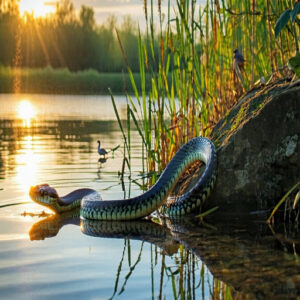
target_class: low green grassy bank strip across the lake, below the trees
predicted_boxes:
[0,66,149,95]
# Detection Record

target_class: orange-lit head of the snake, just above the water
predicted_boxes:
[29,184,59,211]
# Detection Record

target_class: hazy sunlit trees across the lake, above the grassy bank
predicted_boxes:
[0,0,143,72]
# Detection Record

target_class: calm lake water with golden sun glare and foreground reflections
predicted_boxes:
[0,94,300,299]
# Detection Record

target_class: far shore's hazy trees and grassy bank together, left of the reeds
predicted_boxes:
[0,0,147,94]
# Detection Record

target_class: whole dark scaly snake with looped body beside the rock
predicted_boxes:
[29,137,217,221]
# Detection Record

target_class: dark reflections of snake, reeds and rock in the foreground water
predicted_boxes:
[25,209,300,299]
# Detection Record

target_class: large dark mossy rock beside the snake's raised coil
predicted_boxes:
[206,80,300,215]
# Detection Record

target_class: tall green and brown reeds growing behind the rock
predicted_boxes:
[119,0,295,180]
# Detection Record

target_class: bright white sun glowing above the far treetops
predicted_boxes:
[19,0,56,17]
